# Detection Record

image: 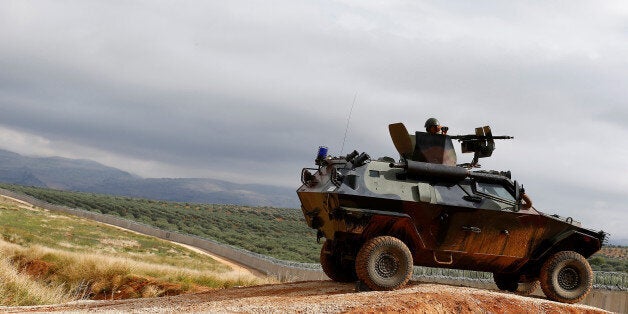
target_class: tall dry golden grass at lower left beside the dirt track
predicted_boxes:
[0,240,269,306]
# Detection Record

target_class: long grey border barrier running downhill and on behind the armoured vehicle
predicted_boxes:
[0,188,628,313]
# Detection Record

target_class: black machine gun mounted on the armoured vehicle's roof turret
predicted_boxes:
[452,125,514,169]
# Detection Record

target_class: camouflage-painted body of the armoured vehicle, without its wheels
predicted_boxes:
[297,127,605,277]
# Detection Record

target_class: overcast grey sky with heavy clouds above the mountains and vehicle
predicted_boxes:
[0,0,628,238]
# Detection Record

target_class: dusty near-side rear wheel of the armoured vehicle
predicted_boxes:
[355,236,413,290]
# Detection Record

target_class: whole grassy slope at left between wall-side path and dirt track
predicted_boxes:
[0,198,268,306]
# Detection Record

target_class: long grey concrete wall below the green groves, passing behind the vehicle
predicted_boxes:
[0,189,628,313]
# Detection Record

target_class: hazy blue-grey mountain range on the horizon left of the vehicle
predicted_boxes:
[0,150,299,208]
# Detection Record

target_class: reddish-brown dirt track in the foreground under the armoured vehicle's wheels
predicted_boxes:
[0,281,606,313]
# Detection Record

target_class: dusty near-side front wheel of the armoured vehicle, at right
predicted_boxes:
[539,251,593,304]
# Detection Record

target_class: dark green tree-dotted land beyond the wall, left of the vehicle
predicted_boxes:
[0,184,320,263]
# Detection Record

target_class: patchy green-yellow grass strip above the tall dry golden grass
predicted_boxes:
[0,203,226,270]
